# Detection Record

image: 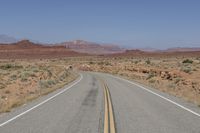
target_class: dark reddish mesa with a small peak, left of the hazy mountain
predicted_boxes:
[0,40,86,59]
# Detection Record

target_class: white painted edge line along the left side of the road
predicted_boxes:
[0,74,83,127]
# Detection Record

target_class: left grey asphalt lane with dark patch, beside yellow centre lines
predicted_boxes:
[0,74,104,133]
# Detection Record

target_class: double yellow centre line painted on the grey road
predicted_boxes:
[102,81,116,133]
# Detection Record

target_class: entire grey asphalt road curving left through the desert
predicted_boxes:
[0,72,200,133]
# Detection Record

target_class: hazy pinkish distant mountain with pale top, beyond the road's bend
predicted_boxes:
[60,40,124,55]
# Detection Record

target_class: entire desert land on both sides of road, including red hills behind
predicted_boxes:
[0,40,200,112]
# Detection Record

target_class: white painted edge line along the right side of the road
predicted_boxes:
[110,75,200,117]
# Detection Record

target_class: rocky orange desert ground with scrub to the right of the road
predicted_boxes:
[77,57,200,106]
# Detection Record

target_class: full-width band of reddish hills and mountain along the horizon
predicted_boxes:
[0,40,200,59]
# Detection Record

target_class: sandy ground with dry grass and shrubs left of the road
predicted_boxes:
[0,60,78,113]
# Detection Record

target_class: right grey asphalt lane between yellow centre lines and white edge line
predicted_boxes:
[99,74,200,133]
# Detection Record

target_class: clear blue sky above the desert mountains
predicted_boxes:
[0,0,200,49]
